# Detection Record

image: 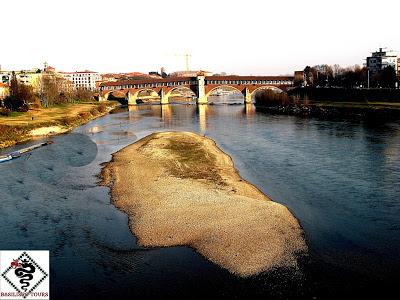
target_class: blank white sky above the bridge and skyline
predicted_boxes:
[0,0,400,75]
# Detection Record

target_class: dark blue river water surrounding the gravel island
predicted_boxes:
[0,105,400,299]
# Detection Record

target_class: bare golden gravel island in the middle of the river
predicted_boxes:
[102,132,307,277]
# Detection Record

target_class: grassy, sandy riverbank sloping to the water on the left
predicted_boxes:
[0,102,118,149]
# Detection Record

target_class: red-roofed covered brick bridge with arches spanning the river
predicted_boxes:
[99,75,294,104]
